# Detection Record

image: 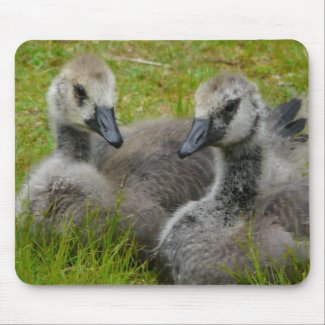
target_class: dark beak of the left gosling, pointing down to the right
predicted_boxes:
[86,106,123,148]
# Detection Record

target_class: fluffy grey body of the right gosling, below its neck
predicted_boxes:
[156,179,309,284]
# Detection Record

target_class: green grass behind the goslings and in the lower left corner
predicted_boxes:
[15,41,308,283]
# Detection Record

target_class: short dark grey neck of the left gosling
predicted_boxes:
[56,124,91,162]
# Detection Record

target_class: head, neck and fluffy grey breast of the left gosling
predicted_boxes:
[16,55,123,230]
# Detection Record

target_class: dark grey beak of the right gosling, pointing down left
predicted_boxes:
[178,118,212,158]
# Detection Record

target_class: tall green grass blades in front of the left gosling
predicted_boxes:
[16,205,156,284]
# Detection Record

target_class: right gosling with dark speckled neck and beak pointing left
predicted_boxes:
[155,75,309,284]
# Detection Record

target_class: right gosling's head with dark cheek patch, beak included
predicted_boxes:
[178,75,266,158]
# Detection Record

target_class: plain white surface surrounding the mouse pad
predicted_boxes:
[0,0,324,324]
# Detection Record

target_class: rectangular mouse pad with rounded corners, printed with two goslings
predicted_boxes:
[15,40,309,285]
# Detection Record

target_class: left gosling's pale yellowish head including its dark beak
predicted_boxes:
[48,55,123,148]
